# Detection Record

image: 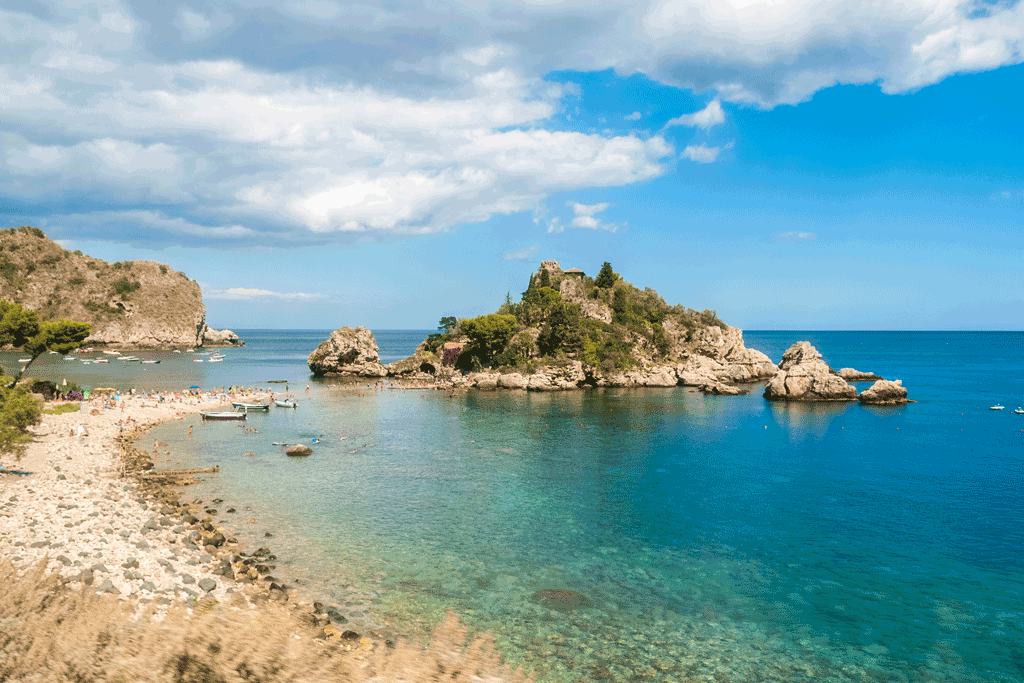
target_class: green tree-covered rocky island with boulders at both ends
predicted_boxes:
[308,261,906,404]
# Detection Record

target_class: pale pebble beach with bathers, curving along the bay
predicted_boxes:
[0,396,247,603]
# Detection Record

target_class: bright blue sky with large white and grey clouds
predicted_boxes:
[0,0,1024,330]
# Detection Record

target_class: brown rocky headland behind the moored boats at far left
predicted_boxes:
[0,227,242,348]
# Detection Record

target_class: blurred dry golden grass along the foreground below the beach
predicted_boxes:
[0,562,524,683]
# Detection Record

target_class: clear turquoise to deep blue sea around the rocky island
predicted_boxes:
[9,330,1024,682]
